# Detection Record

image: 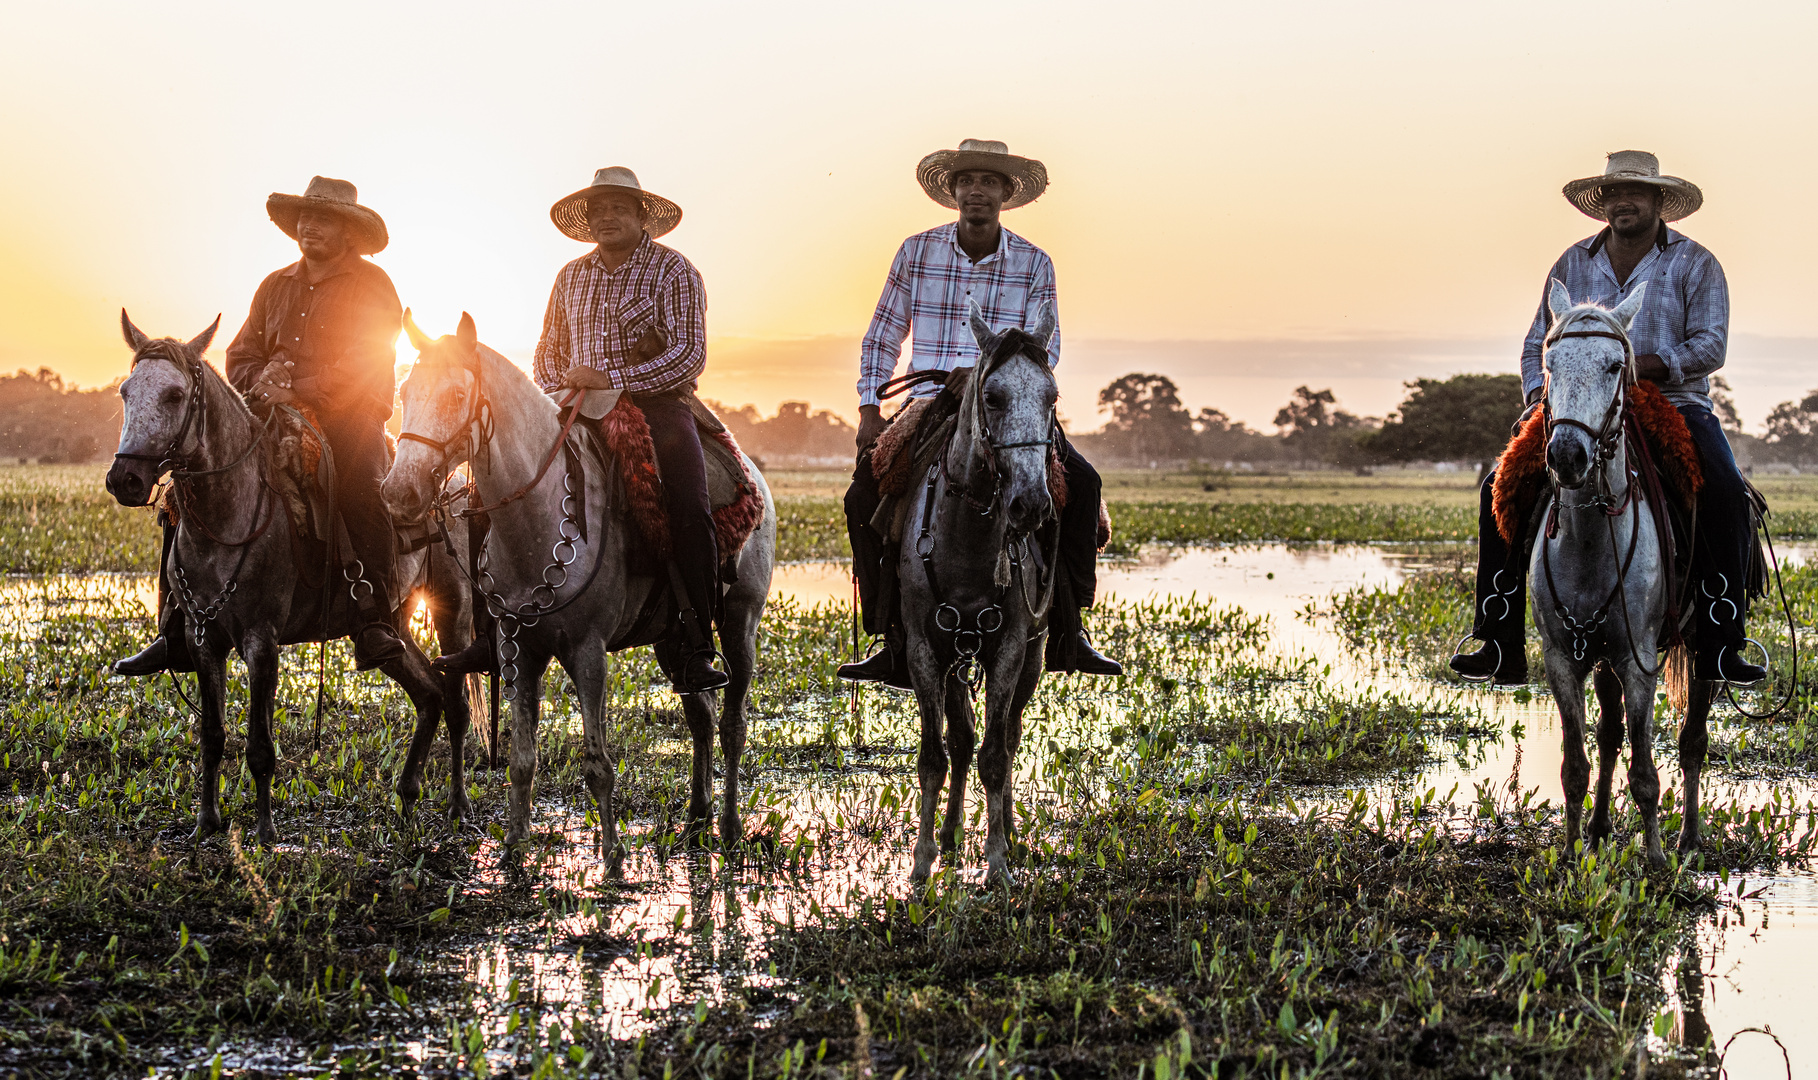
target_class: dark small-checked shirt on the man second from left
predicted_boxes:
[531,233,707,395]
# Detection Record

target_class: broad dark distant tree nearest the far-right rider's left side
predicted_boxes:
[1365,375,1522,465]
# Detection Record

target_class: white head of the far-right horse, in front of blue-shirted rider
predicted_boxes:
[1545,282,1647,489]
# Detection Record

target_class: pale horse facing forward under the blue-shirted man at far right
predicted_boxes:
[1529,282,1714,867]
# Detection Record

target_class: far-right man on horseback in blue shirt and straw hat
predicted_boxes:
[1451,151,1767,684]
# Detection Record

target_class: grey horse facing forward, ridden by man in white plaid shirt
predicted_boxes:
[898,304,1060,882]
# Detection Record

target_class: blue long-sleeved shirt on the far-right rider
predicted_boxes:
[1522,224,1729,409]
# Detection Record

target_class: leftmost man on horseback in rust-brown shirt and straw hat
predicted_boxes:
[115,176,404,675]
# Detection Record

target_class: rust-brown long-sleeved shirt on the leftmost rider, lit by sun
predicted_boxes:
[227,258,404,424]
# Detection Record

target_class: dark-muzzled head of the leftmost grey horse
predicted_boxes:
[107,307,222,505]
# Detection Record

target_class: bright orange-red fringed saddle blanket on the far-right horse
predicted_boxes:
[1491,382,1703,544]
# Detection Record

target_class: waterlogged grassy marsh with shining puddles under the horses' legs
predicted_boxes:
[0,544,1818,1076]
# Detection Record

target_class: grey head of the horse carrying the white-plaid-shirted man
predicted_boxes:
[960,296,1060,533]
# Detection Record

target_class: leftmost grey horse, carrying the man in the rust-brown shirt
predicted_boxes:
[107,311,476,844]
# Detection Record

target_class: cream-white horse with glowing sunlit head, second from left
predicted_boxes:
[382,313,776,867]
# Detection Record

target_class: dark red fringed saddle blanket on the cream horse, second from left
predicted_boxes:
[600,396,764,562]
